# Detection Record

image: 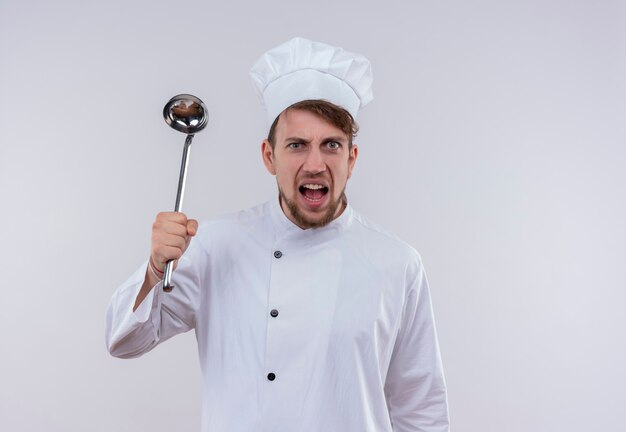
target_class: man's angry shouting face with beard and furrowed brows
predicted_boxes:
[262,109,358,229]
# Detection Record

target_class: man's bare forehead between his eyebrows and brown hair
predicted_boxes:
[276,108,348,140]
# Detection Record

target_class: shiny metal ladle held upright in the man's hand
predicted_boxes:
[163,94,209,292]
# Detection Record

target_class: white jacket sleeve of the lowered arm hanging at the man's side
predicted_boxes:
[385,258,450,432]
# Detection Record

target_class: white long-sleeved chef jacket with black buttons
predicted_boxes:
[106,200,449,432]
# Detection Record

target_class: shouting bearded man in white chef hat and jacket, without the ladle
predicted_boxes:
[107,38,449,432]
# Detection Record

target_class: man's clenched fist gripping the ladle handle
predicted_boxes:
[150,212,198,271]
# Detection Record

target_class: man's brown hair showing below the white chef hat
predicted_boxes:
[267,99,359,149]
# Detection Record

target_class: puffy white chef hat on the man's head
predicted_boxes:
[250,37,374,125]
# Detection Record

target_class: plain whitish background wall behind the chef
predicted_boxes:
[0,0,626,432]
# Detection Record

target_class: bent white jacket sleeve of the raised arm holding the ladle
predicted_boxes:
[105,238,204,358]
